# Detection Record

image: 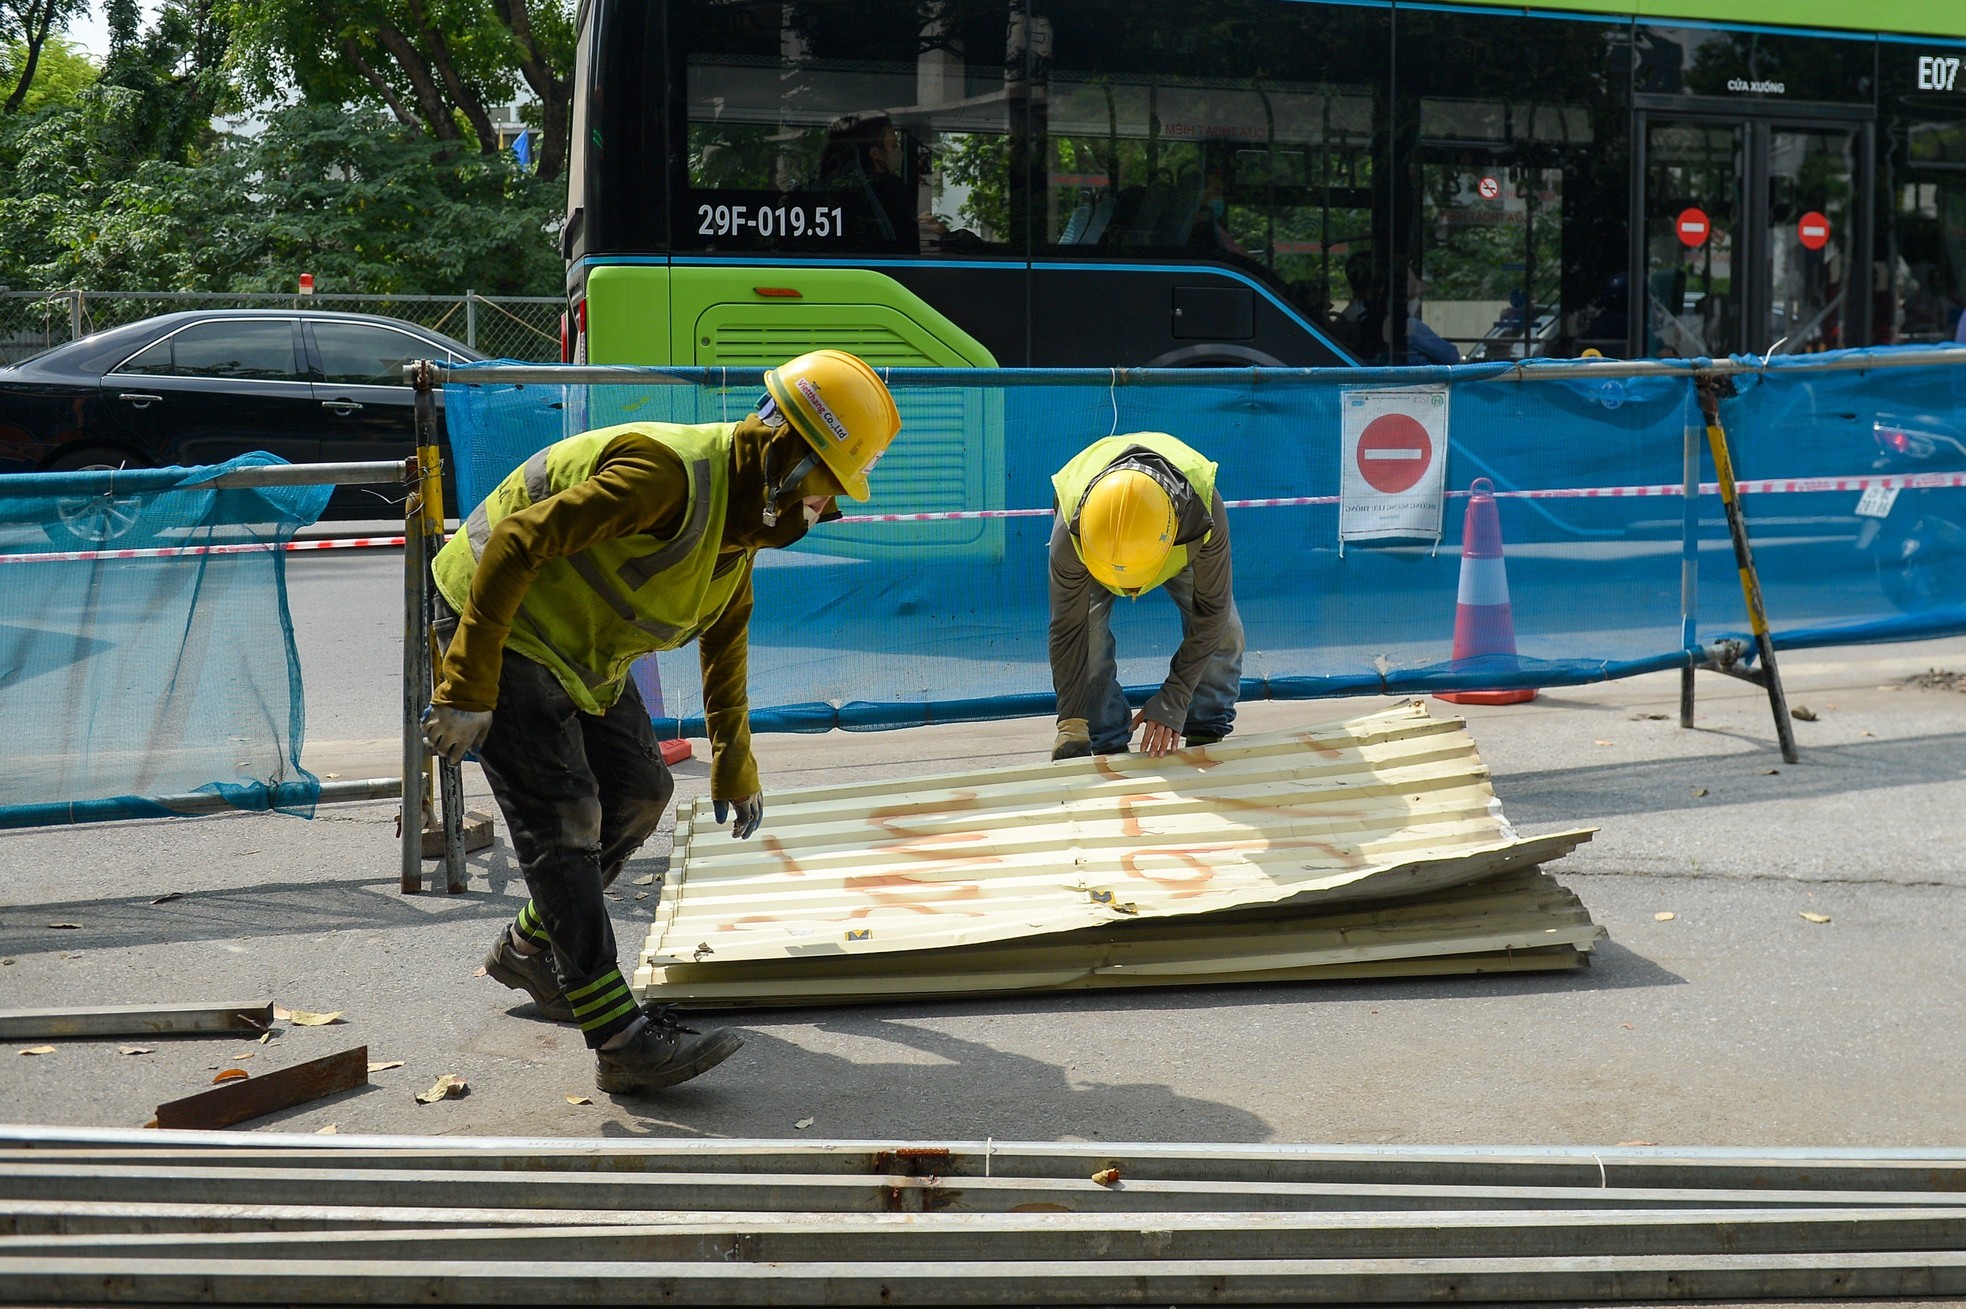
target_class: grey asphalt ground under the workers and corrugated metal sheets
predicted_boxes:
[0,552,1966,1146]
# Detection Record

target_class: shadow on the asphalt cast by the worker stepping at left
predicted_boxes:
[602,1014,1274,1142]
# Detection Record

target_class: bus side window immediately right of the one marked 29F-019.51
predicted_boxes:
[1032,0,1388,330]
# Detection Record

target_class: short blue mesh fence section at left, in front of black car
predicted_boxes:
[0,454,332,827]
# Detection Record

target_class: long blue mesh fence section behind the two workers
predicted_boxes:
[446,352,1966,735]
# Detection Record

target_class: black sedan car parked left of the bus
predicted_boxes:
[0,309,484,519]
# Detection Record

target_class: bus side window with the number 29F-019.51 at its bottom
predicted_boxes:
[670,0,1009,256]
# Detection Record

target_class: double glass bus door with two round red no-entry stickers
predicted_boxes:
[1634,114,1872,358]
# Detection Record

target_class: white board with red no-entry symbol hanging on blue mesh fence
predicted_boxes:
[1339,385,1447,542]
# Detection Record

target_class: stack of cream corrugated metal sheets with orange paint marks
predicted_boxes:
[635,704,1602,1006]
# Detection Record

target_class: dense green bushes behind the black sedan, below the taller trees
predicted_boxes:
[0,100,562,295]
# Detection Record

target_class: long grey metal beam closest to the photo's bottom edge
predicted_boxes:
[0,1252,1966,1305]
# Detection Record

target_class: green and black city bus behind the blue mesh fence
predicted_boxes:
[562,0,1966,368]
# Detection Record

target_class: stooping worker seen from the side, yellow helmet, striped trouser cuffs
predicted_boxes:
[423,350,900,1093]
